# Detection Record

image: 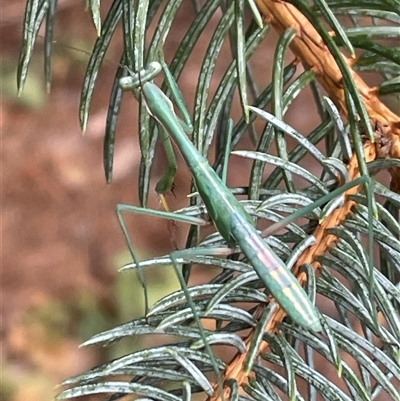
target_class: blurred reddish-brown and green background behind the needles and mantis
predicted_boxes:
[0,0,332,401]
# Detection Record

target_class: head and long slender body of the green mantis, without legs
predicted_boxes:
[120,63,322,331]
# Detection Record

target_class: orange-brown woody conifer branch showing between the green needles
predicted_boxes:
[211,0,400,401]
